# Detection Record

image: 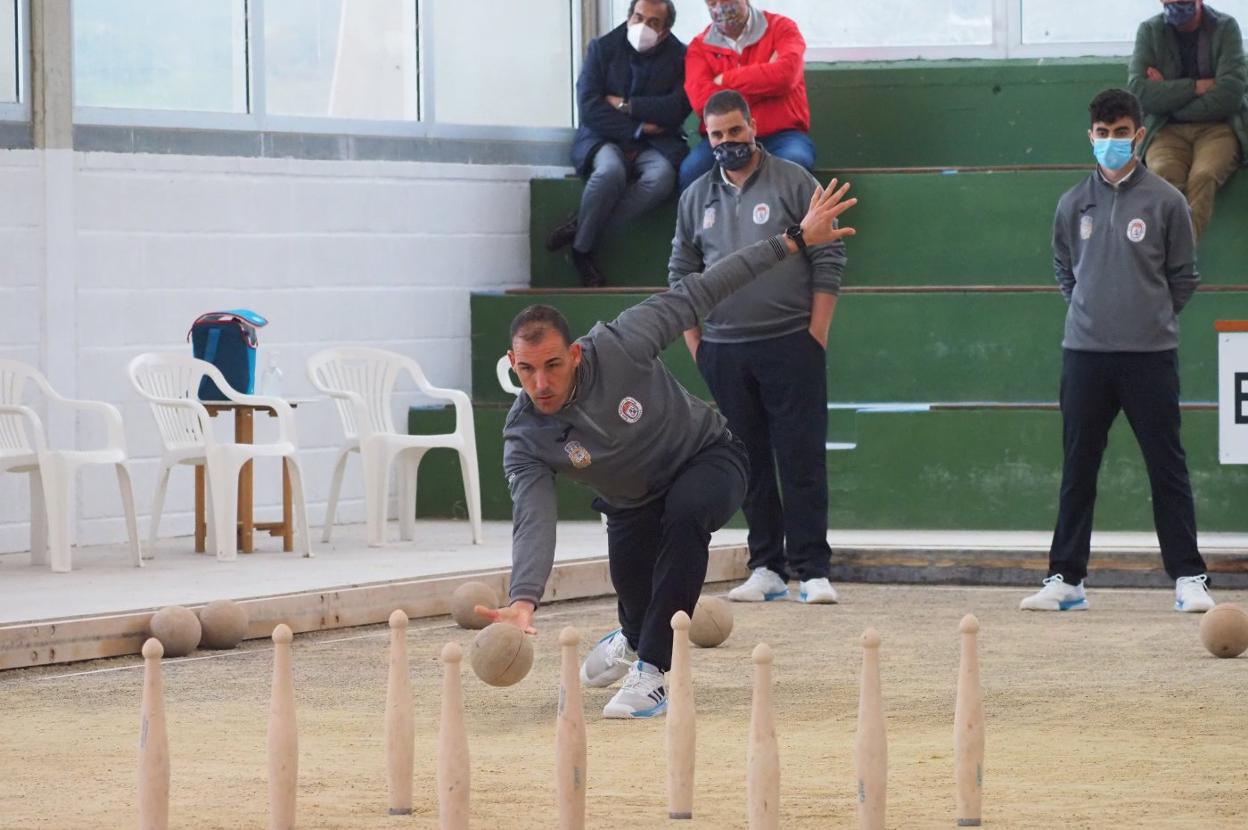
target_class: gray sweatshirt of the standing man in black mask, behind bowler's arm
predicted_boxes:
[668,147,845,343]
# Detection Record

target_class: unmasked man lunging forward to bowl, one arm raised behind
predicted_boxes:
[479,181,856,718]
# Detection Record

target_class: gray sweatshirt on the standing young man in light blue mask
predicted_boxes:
[1053,165,1201,352]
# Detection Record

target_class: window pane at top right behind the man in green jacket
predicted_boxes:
[1020,0,1248,44]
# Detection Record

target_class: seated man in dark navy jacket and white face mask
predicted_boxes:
[547,0,689,287]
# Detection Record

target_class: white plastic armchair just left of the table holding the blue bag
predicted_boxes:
[129,353,312,562]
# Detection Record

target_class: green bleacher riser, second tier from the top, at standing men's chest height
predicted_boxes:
[530,170,1248,288]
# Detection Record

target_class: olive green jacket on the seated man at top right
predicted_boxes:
[1127,6,1248,164]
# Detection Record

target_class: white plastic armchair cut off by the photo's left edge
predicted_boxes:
[0,359,144,572]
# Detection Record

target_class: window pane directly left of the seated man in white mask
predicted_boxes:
[424,0,580,127]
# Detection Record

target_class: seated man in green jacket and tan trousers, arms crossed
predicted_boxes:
[1128,0,1248,240]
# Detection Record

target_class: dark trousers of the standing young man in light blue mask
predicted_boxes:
[1048,349,1204,584]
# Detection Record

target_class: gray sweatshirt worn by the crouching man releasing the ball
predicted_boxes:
[503,233,787,603]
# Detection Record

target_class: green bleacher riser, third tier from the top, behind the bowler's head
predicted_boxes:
[472,292,1248,403]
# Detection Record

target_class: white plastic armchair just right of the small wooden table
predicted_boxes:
[307,347,482,547]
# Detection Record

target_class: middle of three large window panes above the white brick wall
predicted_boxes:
[265,0,418,121]
